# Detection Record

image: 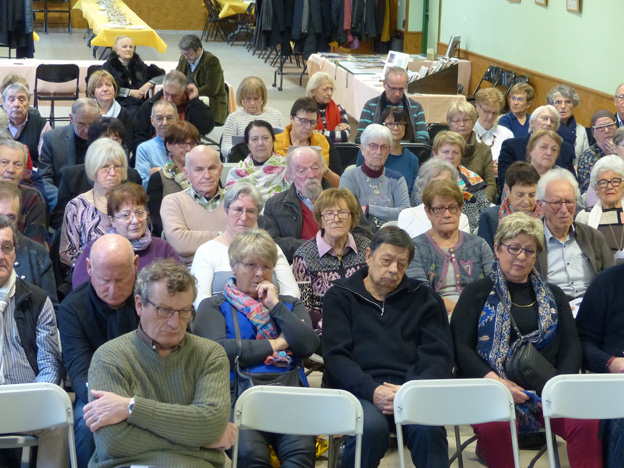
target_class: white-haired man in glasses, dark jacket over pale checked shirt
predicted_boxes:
[535,169,614,300]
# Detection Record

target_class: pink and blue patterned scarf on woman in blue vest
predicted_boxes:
[223,278,292,367]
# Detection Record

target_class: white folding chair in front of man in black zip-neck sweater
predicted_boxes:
[394,379,520,468]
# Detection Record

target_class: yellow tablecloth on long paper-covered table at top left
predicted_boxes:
[74,0,167,54]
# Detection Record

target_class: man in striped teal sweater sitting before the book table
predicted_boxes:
[355,67,430,144]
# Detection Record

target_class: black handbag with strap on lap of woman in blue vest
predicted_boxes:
[230,307,303,397]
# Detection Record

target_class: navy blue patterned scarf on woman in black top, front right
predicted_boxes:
[476,260,559,432]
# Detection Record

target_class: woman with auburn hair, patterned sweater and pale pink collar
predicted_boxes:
[293,188,370,330]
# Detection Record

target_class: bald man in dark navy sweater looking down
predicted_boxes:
[57,234,139,468]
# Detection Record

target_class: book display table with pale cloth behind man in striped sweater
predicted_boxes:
[308,54,471,124]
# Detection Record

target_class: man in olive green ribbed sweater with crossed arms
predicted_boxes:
[84,260,236,468]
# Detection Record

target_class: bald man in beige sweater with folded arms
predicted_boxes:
[160,145,225,265]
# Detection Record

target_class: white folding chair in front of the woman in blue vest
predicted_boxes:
[232,385,364,468]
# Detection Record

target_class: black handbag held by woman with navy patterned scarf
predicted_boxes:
[505,313,557,396]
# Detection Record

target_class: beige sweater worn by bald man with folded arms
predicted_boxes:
[160,192,225,265]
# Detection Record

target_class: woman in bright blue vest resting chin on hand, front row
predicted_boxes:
[192,229,319,468]
